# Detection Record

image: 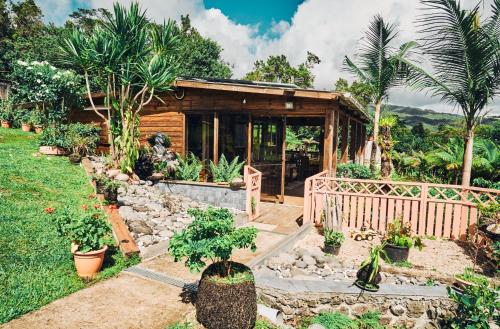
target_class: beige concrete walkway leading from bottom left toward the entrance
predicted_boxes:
[0,204,296,329]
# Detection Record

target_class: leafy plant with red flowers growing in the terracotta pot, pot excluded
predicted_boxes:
[65,205,113,253]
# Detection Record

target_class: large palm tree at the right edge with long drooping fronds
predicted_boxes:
[400,0,500,186]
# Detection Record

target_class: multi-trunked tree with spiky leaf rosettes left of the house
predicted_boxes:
[59,2,179,172]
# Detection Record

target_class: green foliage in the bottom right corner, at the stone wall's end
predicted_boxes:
[447,283,500,329]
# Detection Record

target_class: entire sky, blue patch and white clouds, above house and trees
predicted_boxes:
[36,0,500,115]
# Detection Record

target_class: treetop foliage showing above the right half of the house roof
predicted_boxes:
[244,52,321,88]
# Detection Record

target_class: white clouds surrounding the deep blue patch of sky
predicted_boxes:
[47,0,500,114]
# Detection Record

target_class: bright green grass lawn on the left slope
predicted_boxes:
[0,128,137,323]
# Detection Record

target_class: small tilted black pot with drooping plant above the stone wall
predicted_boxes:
[354,243,385,292]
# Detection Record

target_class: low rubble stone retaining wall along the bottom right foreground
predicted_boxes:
[257,279,455,329]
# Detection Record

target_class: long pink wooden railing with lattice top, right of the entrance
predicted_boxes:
[304,171,500,239]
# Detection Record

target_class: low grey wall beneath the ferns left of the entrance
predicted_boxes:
[156,181,246,211]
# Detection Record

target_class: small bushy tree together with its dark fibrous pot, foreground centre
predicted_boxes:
[169,207,257,329]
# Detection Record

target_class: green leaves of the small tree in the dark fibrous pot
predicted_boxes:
[169,207,257,277]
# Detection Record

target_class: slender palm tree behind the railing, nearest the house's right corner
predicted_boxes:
[344,15,416,172]
